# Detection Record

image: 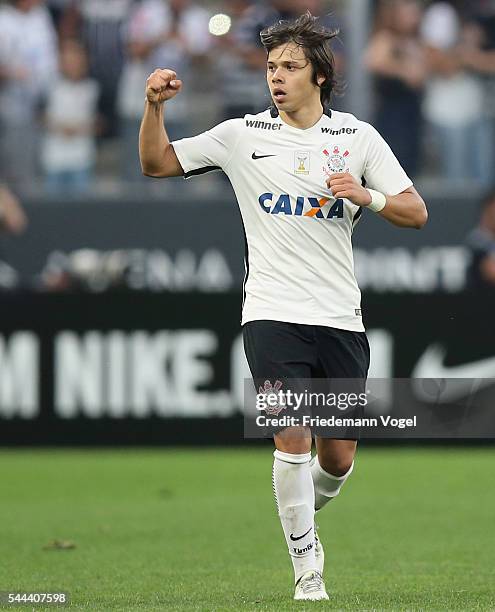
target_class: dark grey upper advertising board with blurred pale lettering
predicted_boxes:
[0,195,477,293]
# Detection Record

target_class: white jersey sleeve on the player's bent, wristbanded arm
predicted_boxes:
[364,125,413,195]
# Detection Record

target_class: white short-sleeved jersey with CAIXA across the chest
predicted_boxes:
[172,110,412,331]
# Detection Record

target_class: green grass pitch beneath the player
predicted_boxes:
[0,445,495,612]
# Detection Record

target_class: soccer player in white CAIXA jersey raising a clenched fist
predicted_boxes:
[140,13,427,600]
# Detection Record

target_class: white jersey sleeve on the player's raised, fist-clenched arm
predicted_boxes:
[171,119,242,178]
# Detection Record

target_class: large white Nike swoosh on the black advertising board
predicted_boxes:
[411,344,495,404]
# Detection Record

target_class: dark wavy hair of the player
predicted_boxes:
[260,11,339,108]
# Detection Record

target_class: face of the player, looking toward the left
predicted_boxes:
[267,43,320,113]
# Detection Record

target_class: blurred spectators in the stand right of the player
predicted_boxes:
[365,0,495,187]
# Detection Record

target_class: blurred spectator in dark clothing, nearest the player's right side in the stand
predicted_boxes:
[365,0,427,177]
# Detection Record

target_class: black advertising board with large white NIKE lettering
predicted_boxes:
[0,293,495,444]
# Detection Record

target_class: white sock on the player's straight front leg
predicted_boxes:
[273,450,316,582]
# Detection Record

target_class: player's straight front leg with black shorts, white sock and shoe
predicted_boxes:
[243,321,327,599]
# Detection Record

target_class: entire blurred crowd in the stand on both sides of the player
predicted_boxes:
[0,0,495,193]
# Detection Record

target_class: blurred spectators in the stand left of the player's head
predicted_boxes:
[0,0,340,194]
